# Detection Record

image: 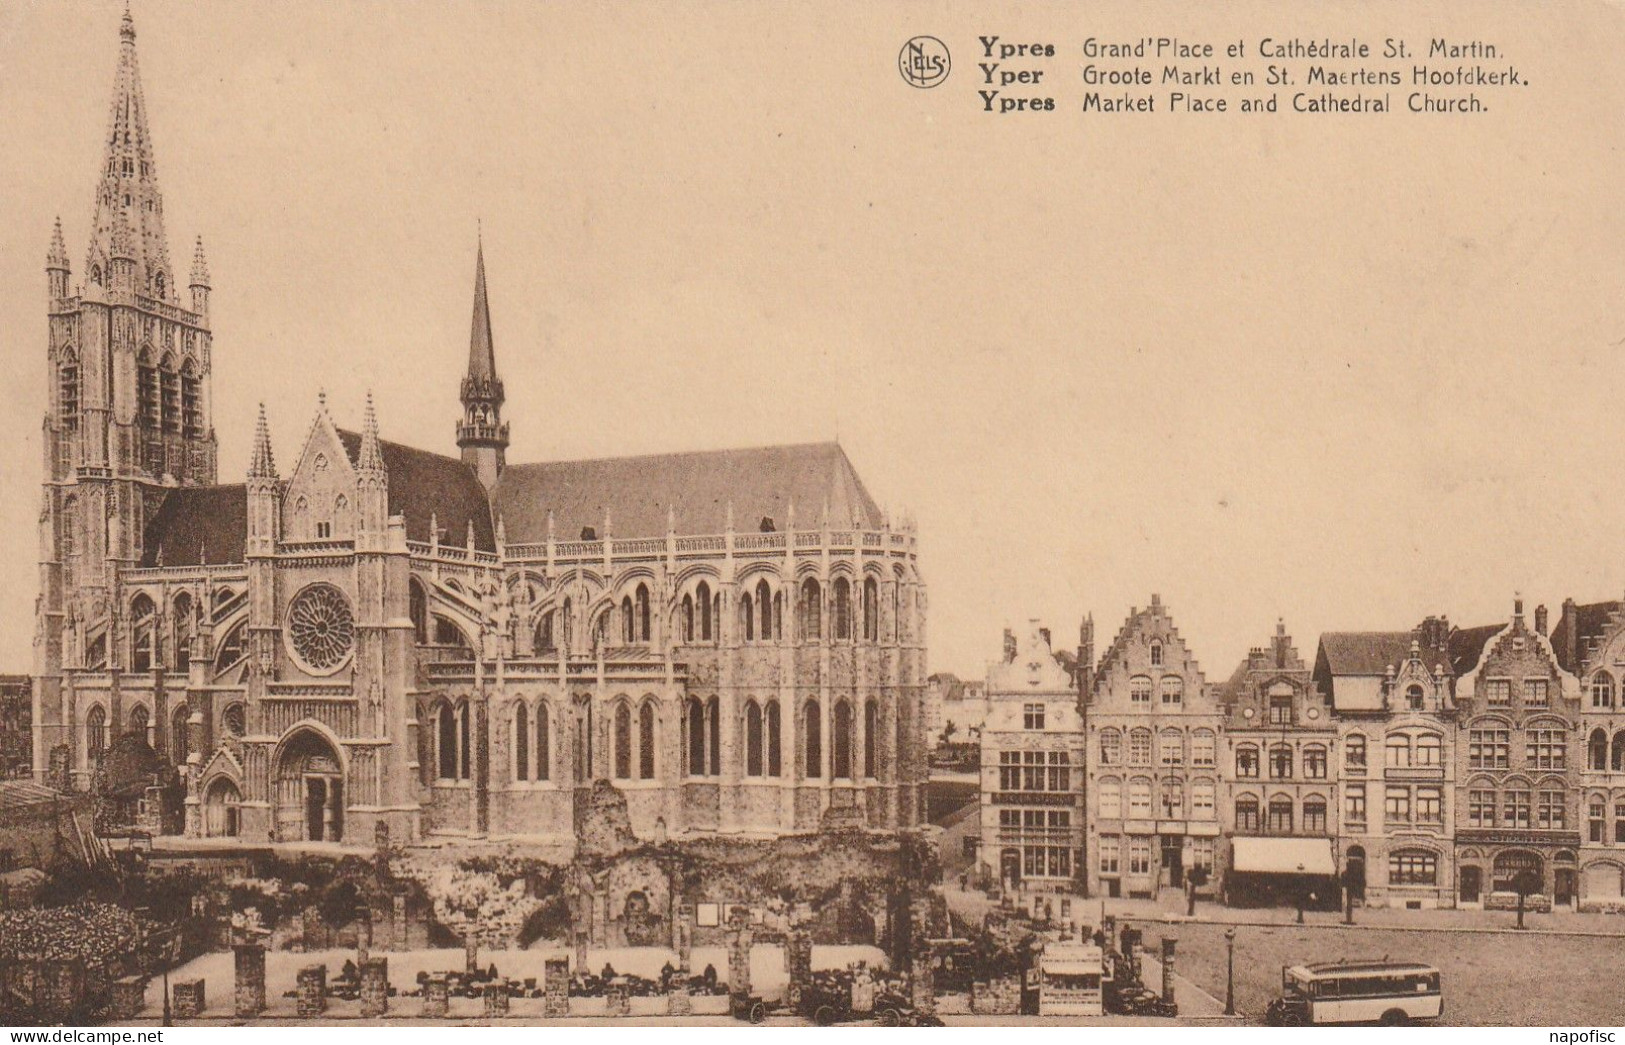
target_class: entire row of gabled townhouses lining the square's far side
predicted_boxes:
[962,596,1625,913]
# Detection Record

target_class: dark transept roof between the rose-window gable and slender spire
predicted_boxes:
[338,429,497,551]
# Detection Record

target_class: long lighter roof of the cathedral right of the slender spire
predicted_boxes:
[494,442,881,543]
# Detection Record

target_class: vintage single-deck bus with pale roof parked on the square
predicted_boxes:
[1266,959,1445,1027]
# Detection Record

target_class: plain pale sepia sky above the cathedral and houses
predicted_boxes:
[0,0,1625,679]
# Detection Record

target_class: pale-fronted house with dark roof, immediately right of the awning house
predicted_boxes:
[1313,618,1485,908]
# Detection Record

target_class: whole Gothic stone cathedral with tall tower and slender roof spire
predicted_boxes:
[33,13,926,845]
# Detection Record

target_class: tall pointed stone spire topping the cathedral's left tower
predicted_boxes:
[86,10,176,299]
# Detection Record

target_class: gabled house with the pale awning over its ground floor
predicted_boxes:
[1215,621,1341,904]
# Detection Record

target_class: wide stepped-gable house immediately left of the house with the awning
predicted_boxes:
[1084,595,1220,897]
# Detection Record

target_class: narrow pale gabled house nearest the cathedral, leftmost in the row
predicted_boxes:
[982,621,1084,892]
